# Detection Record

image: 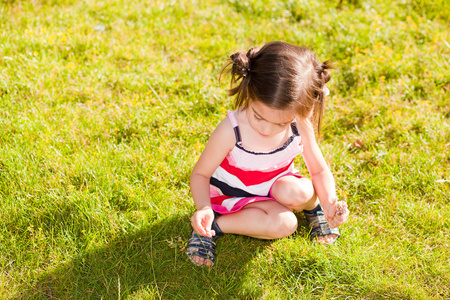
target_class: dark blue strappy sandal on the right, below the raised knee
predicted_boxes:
[303,204,340,244]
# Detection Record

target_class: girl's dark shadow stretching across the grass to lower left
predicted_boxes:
[15,216,271,300]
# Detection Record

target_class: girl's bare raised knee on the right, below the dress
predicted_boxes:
[272,176,316,210]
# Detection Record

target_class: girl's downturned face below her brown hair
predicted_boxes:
[246,101,295,138]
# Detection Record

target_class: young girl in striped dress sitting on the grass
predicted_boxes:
[187,42,349,266]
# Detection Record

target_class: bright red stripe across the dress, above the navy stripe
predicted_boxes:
[220,158,294,186]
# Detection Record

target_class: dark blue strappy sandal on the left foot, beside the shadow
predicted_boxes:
[186,220,224,267]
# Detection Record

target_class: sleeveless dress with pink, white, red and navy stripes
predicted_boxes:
[210,111,303,214]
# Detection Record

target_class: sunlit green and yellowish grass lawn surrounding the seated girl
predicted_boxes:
[0,0,450,299]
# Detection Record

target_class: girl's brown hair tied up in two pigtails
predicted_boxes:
[222,42,332,134]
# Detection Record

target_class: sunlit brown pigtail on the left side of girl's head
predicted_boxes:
[221,48,257,108]
